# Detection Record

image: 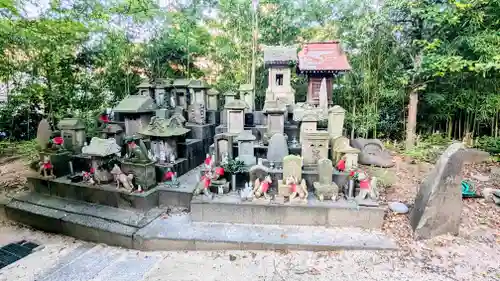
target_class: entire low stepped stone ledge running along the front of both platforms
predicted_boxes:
[0,193,397,251]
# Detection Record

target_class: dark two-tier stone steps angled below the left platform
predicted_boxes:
[5,193,163,248]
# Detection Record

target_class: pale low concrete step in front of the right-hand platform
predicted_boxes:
[134,214,397,251]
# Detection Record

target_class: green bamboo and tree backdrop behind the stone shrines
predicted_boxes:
[0,0,500,144]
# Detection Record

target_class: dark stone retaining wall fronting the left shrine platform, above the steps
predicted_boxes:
[27,177,158,210]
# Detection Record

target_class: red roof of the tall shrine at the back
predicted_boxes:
[298,40,351,73]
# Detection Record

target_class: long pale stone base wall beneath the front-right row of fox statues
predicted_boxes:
[191,194,385,229]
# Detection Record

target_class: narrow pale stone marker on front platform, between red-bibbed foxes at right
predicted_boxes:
[313,158,339,201]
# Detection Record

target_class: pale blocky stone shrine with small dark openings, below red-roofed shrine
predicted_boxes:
[302,131,329,165]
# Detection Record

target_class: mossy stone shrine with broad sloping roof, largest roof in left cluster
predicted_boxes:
[113,95,157,136]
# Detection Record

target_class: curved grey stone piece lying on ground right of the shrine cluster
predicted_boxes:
[351,138,394,168]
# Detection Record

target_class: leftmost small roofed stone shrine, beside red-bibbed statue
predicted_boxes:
[57,118,85,153]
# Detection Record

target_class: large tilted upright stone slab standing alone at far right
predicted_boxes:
[410,143,489,239]
